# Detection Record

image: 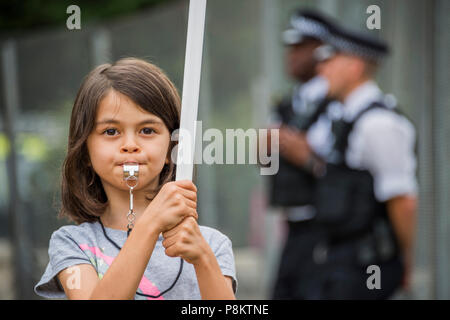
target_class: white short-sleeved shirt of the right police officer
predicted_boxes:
[330,81,417,202]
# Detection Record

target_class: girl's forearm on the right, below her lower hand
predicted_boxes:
[194,251,236,300]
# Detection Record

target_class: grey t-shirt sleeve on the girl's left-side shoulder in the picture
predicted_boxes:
[34,227,91,298]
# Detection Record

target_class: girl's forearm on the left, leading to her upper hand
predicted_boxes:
[90,217,159,300]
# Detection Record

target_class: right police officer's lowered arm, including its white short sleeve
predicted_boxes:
[354,110,417,287]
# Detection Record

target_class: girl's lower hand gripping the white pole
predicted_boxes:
[162,217,214,265]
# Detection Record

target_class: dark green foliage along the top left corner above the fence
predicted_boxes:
[0,0,174,32]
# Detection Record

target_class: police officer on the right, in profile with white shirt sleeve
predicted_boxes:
[310,23,417,299]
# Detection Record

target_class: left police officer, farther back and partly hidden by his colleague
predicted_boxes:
[270,10,339,299]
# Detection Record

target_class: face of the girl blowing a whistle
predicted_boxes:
[87,90,170,193]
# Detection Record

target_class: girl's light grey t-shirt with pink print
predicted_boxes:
[34,222,237,300]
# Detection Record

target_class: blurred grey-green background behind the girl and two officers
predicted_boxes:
[0,0,450,299]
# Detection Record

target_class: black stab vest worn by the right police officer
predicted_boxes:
[314,102,399,262]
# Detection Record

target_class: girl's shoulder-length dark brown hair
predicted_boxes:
[59,58,181,224]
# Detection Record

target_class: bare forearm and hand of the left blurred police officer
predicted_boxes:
[279,126,311,167]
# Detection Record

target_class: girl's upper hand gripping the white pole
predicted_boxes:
[144,180,198,233]
